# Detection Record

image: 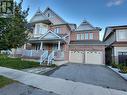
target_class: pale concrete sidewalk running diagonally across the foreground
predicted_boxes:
[0,67,127,95]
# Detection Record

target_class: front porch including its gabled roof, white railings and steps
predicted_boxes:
[11,30,67,64]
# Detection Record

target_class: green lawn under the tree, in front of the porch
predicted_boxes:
[0,54,40,70]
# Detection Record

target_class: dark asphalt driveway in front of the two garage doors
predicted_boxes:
[50,64,127,91]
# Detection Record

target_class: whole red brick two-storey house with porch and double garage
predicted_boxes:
[13,7,105,64]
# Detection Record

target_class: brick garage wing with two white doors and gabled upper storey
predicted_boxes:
[69,20,105,64]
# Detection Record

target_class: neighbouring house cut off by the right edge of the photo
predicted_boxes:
[103,25,127,64]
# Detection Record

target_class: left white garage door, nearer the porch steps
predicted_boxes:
[69,51,84,63]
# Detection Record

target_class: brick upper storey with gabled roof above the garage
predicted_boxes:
[71,20,101,40]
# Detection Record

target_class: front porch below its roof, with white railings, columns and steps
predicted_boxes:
[12,40,66,64]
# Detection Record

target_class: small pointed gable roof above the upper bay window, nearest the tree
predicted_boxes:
[30,9,48,23]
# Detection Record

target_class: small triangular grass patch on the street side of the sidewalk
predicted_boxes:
[0,76,16,88]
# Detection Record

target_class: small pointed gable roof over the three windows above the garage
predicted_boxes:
[76,20,100,31]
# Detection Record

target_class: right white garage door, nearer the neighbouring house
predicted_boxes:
[85,51,103,64]
